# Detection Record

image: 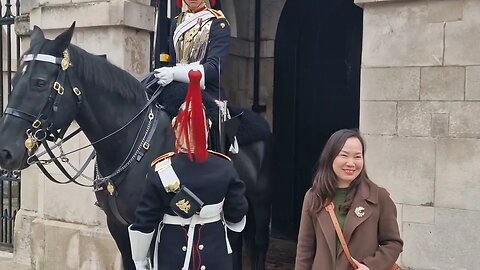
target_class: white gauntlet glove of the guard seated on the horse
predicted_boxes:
[154,64,205,89]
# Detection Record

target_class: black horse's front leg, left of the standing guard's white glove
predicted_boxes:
[107,216,135,270]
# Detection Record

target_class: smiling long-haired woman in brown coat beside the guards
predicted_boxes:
[295,129,403,270]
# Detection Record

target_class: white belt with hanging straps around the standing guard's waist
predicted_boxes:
[158,200,232,270]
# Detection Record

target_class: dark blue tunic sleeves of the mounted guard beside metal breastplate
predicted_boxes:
[169,8,230,100]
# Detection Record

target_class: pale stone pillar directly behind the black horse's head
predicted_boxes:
[14,0,155,270]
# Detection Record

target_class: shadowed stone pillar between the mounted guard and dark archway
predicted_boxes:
[222,0,285,123]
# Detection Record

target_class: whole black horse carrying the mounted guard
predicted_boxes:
[0,23,271,270]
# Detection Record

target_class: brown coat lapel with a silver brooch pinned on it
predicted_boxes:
[343,181,378,248]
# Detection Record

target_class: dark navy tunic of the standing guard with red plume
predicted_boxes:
[132,153,248,270]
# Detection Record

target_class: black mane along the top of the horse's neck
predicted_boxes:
[69,45,145,100]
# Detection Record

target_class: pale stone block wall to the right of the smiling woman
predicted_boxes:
[355,0,480,269]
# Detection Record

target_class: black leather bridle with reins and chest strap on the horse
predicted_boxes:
[5,49,163,225]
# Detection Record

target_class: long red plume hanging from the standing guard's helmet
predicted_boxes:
[176,70,208,162]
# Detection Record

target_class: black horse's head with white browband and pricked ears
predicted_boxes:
[0,23,81,170]
